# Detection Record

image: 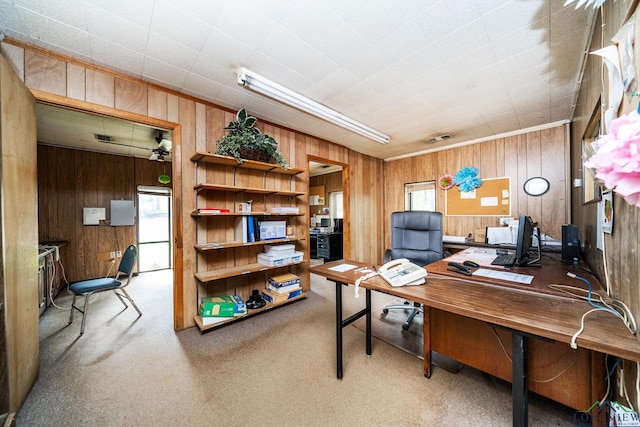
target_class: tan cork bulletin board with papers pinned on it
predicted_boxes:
[444,177,511,217]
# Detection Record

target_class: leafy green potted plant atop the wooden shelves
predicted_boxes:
[216,108,288,169]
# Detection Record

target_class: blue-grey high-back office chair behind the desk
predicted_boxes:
[382,211,442,331]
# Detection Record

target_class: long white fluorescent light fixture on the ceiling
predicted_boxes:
[238,68,391,144]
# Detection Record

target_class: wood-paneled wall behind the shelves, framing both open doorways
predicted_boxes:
[1,39,384,329]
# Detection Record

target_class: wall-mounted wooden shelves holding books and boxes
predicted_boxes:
[191,152,308,331]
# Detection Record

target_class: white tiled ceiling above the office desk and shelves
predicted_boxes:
[0,0,595,159]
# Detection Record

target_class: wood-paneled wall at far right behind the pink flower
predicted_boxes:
[571,1,640,410]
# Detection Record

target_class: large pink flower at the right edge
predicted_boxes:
[584,111,640,207]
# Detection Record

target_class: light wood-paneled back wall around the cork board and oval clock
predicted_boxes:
[384,126,569,244]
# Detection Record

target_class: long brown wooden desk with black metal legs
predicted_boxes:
[311,261,640,425]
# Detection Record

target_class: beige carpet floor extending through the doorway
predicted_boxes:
[16,272,573,427]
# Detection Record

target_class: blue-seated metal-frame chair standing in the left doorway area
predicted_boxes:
[69,245,142,335]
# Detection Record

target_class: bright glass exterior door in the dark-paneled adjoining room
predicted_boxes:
[138,185,173,273]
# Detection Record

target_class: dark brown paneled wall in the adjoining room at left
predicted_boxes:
[38,145,171,282]
